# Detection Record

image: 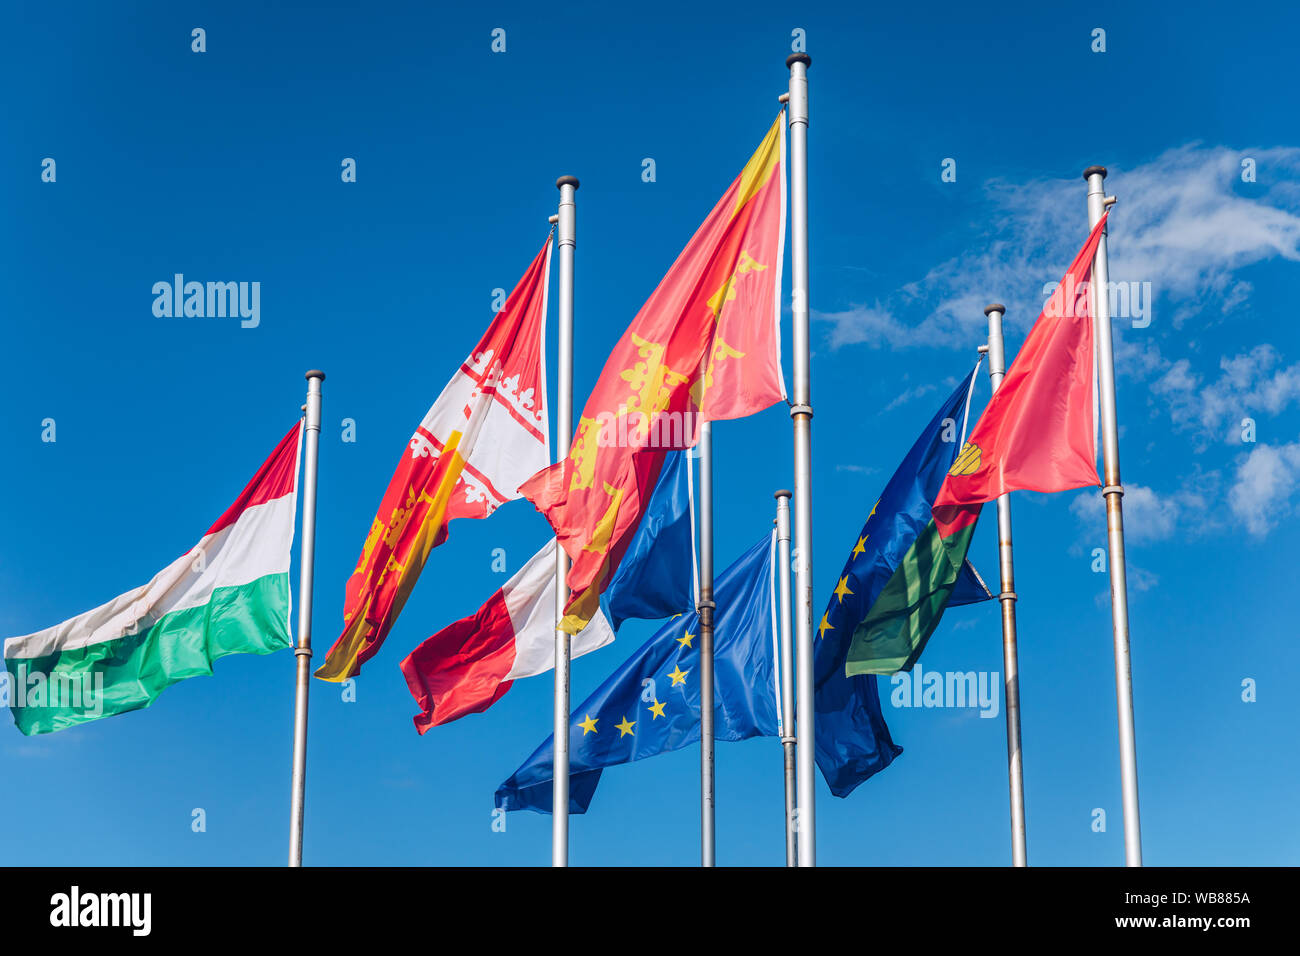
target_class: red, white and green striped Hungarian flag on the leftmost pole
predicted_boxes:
[4,424,302,735]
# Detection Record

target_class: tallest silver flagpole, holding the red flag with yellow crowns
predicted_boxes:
[785,53,816,866]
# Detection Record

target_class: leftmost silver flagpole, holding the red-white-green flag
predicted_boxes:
[289,368,325,866]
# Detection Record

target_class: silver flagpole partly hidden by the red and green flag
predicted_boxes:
[984,303,1030,866]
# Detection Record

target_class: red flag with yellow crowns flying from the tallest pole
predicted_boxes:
[521,113,785,633]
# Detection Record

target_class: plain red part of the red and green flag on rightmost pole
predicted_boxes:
[933,216,1106,541]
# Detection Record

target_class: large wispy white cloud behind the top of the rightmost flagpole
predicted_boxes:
[814,144,1300,349]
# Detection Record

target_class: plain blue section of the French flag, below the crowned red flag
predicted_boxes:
[601,451,696,631]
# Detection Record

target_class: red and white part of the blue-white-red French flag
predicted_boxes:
[402,538,614,734]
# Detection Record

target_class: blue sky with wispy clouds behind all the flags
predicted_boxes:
[0,3,1300,865]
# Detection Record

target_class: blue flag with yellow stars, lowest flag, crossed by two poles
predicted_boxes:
[497,536,776,813]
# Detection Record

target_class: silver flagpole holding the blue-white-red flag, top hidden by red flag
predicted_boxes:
[696,421,718,866]
